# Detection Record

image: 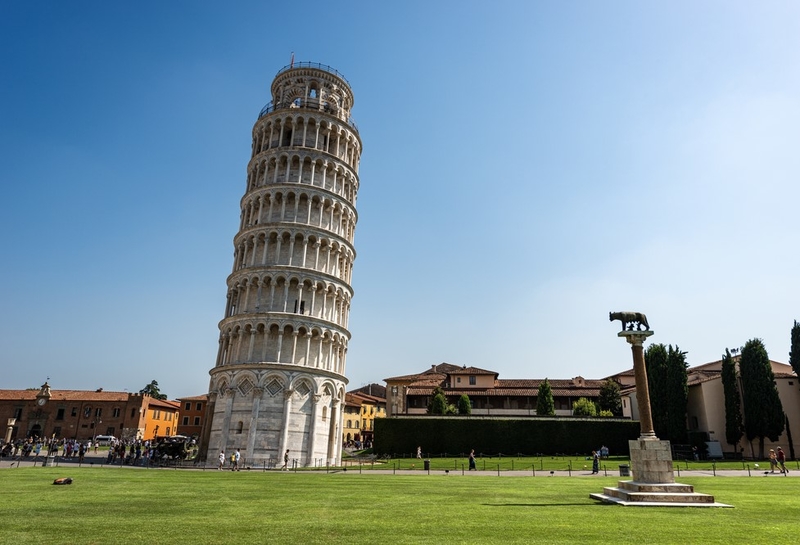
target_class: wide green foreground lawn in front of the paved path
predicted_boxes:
[0,467,800,545]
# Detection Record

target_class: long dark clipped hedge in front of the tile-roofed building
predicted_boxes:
[373,416,639,456]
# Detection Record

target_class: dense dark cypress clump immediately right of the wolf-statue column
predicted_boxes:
[644,344,689,443]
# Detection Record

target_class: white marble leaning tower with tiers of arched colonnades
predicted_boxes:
[203,63,361,466]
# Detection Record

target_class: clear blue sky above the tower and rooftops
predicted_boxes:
[0,0,800,397]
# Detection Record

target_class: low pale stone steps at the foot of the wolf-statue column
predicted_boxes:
[589,481,732,507]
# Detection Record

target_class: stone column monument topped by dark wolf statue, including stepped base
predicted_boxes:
[589,312,730,507]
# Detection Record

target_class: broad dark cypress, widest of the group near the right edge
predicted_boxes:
[739,339,784,458]
